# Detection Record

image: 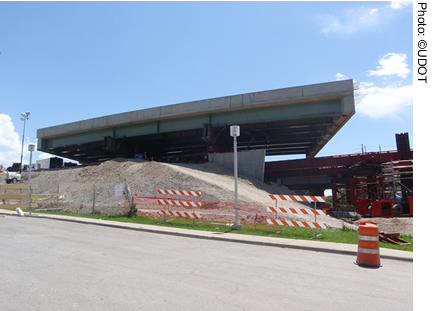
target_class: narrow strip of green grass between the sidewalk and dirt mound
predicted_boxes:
[35,212,413,252]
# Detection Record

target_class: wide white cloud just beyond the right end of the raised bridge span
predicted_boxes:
[355,83,413,119]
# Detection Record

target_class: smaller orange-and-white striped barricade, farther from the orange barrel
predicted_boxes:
[157,189,202,224]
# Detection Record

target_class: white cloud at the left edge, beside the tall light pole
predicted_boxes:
[0,114,21,169]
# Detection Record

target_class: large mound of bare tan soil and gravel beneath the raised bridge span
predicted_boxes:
[0,159,412,234]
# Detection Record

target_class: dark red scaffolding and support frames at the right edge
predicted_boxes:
[332,133,413,217]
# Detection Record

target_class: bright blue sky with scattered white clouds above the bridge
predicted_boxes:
[0,1,415,167]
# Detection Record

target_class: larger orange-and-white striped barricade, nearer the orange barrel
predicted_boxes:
[267,194,327,238]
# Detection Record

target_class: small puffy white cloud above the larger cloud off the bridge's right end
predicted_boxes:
[368,53,411,79]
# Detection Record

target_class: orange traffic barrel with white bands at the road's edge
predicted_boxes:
[356,221,381,267]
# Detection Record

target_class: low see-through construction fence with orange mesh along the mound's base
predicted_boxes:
[0,183,344,232]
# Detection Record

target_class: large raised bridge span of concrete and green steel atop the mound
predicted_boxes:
[37,80,355,178]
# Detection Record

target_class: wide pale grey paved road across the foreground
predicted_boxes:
[0,216,413,311]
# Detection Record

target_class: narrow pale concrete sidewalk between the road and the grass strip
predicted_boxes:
[0,209,413,262]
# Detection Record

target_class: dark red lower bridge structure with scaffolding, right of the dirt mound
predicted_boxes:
[264,141,414,217]
